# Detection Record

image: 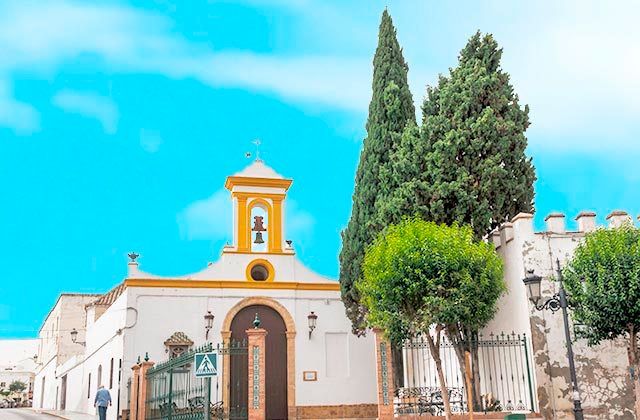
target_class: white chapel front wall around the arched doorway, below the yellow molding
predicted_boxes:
[123,288,377,405]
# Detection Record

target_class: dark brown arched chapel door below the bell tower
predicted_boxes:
[230,305,287,420]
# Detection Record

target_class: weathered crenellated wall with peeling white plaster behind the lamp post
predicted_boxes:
[488,210,640,420]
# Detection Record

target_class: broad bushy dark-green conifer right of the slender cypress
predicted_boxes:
[422,32,536,238]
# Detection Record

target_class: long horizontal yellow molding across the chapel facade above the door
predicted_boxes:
[124,279,340,292]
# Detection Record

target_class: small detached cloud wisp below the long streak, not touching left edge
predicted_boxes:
[53,90,118,134]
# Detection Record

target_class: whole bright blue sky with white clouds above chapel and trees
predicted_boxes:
[0,0,640,337]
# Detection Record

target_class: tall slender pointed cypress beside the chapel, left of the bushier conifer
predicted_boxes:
[340,9,415,333]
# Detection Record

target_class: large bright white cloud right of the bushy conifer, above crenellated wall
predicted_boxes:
[500,2,640,146]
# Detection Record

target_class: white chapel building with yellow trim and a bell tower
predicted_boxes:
[33,160,377,420]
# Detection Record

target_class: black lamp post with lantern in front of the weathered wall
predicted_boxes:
[522,259,584,420]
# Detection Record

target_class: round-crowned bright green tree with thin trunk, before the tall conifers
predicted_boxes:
[357,218,506,418]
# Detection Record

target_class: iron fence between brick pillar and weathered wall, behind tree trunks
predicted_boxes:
[394,333,535,415]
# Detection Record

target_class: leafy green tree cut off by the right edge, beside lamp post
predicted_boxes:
[564,224,640,418]
